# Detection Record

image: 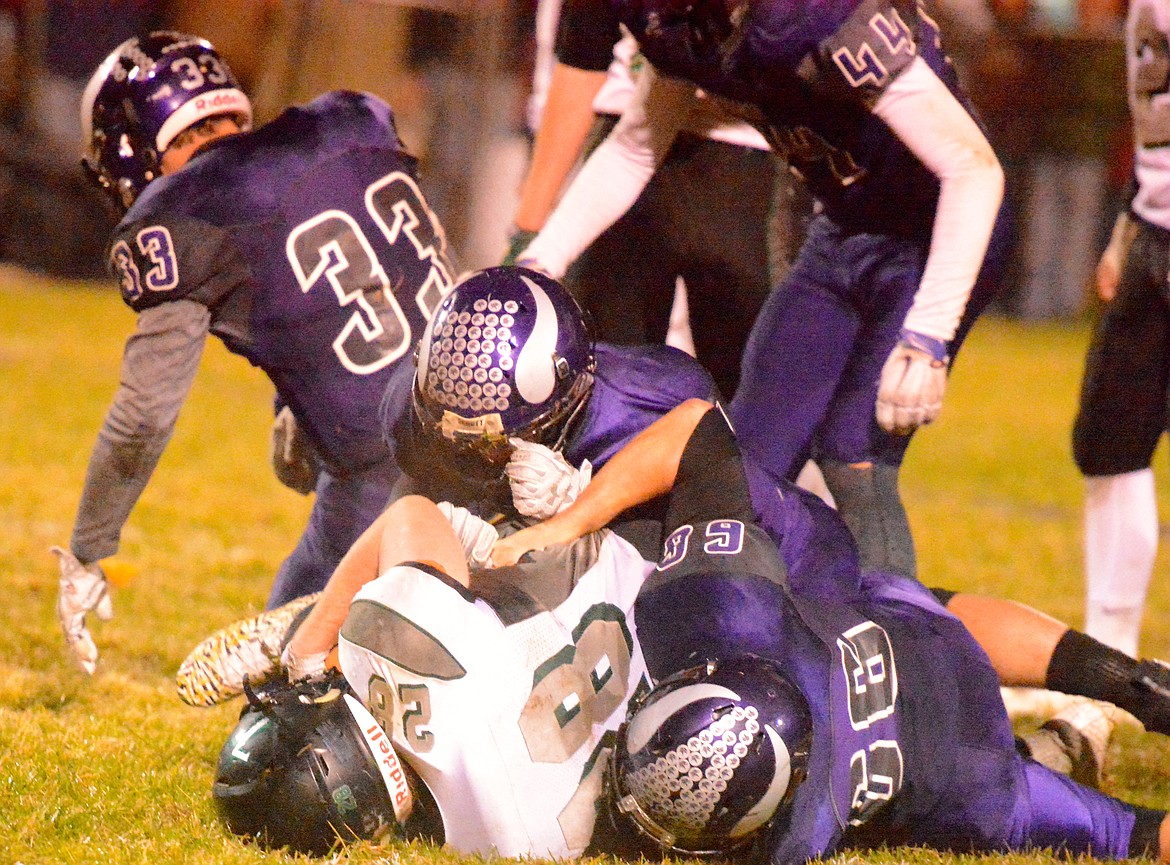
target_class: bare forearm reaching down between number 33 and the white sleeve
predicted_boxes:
[514,63,606,232]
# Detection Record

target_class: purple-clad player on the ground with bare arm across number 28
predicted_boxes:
[493,403,1170,865]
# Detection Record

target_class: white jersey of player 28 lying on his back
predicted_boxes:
[339,531,653,858]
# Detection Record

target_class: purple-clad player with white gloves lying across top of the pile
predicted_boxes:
[369,267,1170,749]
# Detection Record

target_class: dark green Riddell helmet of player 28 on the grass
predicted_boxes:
[212,671,441,856]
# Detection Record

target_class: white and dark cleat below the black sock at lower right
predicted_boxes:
[1021,699,1116,789]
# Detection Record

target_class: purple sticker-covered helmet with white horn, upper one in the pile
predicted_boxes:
[414,267,596,464]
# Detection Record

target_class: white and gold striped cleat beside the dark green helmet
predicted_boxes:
[174,592,321,707]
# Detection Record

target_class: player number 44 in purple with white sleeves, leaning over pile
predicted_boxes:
[519,0,1003,585]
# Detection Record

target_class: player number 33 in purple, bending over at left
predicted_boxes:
[54,32,452,673]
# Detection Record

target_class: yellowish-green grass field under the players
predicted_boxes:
[0,269,1170,865]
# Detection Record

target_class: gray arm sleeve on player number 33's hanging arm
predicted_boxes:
[70,300,211,562]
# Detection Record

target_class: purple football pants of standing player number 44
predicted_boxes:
[729,215,1003,478]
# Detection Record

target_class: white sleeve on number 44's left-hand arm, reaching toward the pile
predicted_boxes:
[518,66,697,280]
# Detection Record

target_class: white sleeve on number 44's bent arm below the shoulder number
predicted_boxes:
[873,57,1004,341]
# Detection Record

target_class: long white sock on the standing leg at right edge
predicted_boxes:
[1085,468,1158,658]
